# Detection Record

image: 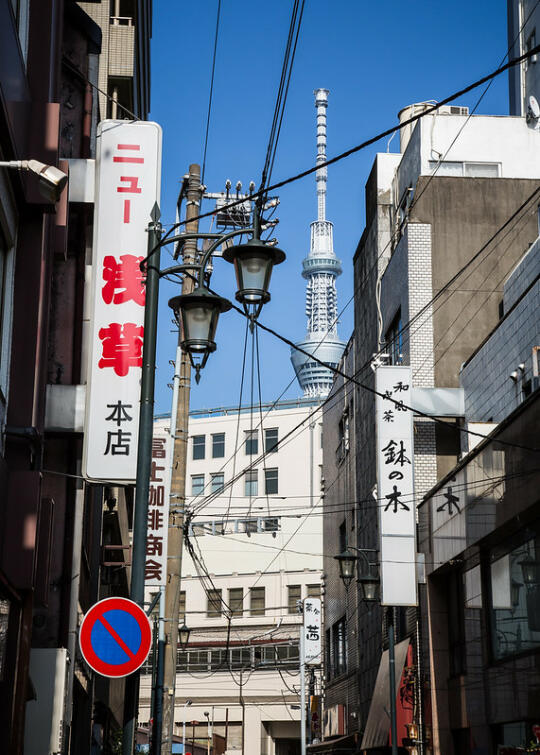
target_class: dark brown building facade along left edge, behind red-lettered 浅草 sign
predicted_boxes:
[0,0,151,755]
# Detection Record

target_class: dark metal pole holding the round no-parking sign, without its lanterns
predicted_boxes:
[122,216,161,755]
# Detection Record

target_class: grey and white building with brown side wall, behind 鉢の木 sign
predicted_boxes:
[319,106,540,755]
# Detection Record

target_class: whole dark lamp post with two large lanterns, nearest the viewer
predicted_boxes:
[122,205,285,755]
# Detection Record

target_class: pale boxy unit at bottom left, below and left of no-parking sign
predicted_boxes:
[24,648,68,755]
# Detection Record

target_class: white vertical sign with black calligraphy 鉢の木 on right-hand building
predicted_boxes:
[375,366,418,606]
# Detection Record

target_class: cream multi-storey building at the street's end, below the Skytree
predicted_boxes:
[139,399,322,755]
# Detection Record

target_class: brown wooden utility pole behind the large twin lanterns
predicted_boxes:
[162,165,202,755]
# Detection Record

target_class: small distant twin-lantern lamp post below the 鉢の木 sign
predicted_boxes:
[334,545,398,755]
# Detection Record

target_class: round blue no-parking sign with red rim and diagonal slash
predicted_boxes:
[79,598,152,678]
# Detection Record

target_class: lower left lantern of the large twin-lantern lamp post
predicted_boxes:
[169,286,232,354]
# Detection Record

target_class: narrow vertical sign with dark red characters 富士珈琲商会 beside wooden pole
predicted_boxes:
[144,428,171,587]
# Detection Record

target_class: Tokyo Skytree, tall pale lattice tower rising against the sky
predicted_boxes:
[291,89,345,398]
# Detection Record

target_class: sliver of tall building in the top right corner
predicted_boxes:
[508,0,540,116]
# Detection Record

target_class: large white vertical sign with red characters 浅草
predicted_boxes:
[83,121,161,483]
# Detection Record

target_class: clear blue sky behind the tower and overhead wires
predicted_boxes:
[150,0,508,413]
